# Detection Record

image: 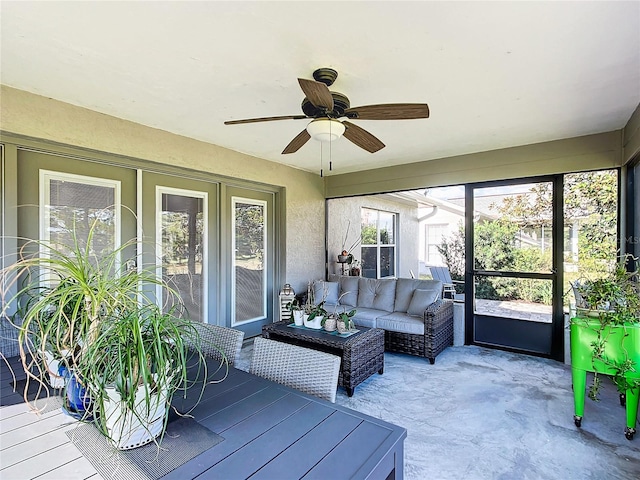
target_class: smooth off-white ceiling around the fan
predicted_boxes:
[0,0,640,174]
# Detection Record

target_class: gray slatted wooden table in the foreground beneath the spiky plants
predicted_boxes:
[0,352,406,480]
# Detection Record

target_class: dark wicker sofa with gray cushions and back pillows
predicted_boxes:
[314,275,453,364]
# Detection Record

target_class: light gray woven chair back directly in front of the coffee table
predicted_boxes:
[249,337,340,403]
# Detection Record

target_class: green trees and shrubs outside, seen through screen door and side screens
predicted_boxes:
[438,170,618,303]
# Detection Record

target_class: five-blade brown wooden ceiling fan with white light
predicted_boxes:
[224,68,429,154]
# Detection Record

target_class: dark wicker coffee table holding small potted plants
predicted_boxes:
[262,320,384,397]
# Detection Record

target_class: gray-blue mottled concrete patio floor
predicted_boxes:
[238,339,640,480]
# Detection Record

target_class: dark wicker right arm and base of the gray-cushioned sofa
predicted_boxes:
[385,300,453,363]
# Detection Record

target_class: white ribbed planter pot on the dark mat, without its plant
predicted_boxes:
[104,378,167,450]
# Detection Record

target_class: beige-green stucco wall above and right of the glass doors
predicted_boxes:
[0,85,325,290]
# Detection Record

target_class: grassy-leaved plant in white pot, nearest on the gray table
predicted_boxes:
[81,304,195,449]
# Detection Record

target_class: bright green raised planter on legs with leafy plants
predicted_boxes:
[570,255,640,439]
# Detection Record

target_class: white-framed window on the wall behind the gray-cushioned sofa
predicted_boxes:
[361,208,397,278]
